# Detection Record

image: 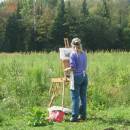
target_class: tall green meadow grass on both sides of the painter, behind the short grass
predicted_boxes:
[0,52,130,119]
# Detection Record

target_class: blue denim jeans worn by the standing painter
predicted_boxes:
[70,75,88,118]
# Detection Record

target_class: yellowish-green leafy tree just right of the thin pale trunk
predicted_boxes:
[36,8,53,51]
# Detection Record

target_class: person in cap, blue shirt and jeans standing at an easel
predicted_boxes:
[64,38,88,122]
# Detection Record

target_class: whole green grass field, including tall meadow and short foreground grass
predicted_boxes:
[0,52,130,130]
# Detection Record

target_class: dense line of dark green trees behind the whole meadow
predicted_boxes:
[0,0,130,52]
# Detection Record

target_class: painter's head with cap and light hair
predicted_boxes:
[71,37,82,52]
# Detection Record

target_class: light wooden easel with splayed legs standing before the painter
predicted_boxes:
[48,38,70,107]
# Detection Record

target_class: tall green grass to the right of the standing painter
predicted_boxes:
[88,52,130,108]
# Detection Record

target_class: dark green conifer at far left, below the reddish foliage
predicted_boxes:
[4,5,24,52]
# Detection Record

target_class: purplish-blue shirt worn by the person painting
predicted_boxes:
[70,51,87,76]
